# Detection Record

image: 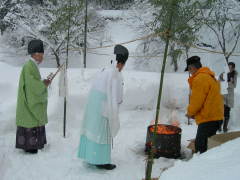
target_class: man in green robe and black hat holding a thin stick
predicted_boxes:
[16,40,51,153]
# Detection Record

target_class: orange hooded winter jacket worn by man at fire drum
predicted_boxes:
[188,67,224,124]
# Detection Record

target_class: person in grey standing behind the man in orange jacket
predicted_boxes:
[219,62,238,132]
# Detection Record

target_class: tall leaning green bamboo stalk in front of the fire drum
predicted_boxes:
[145,0,176,180]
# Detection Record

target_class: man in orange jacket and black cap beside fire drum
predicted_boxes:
[185,56,224,153]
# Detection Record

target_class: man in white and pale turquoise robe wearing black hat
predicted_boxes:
[78,45,128,170]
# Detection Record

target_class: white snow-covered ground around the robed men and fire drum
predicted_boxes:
[0,59,240,180]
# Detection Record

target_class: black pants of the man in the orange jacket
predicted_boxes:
[195,121,222,153]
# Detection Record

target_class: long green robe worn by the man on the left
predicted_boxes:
[16,60,48,128]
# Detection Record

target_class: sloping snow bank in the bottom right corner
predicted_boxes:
[160,138,240,180]
